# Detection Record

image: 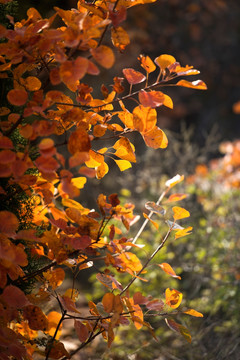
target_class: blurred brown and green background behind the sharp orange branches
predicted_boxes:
[5,0,240,360]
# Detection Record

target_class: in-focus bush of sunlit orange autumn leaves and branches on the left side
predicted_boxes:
[0,0,206,360]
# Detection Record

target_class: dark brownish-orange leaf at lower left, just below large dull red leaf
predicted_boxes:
[23,305,48,331]
